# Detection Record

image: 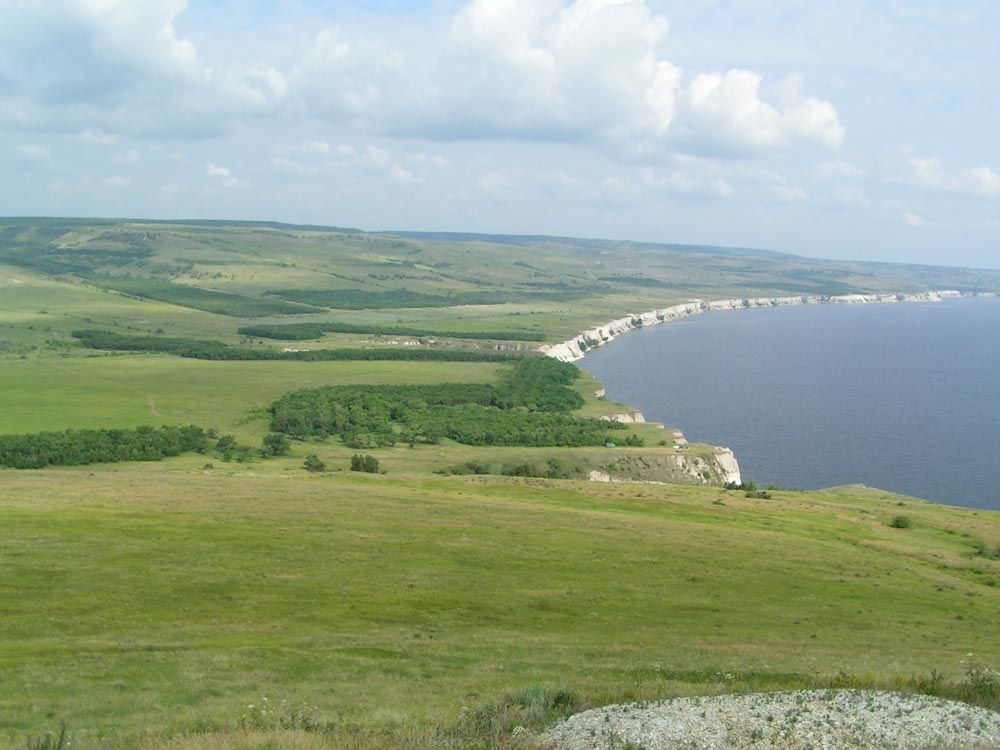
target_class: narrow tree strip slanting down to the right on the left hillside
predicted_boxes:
[88,276,318,318]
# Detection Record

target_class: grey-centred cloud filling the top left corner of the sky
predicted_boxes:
[0,0,287,135]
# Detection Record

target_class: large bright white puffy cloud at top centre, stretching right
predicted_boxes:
[291,0,844,160]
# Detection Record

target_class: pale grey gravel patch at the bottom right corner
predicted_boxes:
[544,690,1000,750]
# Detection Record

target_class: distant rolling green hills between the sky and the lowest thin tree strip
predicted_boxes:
[0,219,1000,360]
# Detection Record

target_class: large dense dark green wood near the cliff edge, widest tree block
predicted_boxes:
[270,357,625,448]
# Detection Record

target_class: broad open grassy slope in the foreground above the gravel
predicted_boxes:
[0,468,1000,741]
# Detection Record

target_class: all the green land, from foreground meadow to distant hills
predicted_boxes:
[0,219,1000,750]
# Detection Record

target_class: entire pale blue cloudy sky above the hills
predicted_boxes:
[0,0,1000,268]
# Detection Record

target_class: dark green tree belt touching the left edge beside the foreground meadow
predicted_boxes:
[0,425,208,469]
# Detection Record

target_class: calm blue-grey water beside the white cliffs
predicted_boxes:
[579,299,1000,509]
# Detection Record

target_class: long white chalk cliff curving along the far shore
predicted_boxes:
[535,289,966,362]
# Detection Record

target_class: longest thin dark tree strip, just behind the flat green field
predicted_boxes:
[72,330,513,362]
